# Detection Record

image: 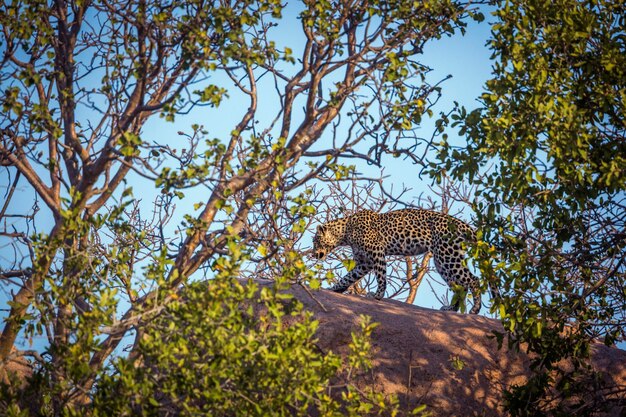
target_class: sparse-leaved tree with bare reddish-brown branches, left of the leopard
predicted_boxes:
[0,0,473,415]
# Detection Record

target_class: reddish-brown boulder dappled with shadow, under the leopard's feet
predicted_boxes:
[263,282,626,416]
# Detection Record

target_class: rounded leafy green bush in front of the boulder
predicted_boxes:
[92,279,397,416]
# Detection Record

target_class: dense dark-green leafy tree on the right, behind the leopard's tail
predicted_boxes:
[433,0,626,415]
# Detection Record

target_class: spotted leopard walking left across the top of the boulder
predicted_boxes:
[312,208,481,314]
